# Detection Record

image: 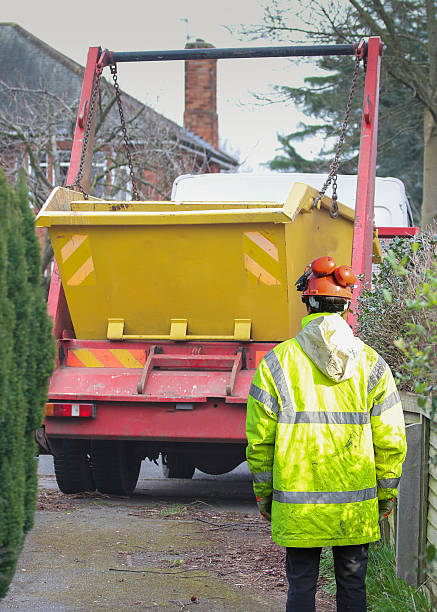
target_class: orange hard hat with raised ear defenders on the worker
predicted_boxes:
[296,256,357,300]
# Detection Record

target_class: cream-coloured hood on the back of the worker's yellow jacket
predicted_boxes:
[296,313,364,382]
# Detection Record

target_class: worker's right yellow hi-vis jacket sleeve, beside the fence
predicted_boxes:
[368,356,407,500]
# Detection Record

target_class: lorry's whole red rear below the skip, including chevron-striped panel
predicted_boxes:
[44,338,274,444]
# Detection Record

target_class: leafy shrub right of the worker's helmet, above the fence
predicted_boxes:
[358,227,437,412]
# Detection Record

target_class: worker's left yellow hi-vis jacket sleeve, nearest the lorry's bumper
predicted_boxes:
[246,359,279,497]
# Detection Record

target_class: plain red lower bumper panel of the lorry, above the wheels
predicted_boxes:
[45,399,246,444]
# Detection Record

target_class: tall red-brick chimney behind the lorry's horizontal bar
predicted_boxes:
[184,38,218,149]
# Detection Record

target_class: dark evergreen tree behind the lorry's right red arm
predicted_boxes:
[269,57,423,219]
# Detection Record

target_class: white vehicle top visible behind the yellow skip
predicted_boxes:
[171,172,413,227]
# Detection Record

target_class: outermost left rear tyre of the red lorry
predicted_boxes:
[54,440,96,493]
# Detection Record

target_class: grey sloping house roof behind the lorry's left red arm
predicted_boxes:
[0,23,239,169]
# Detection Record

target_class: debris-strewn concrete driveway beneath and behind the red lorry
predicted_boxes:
[0,457,285,612]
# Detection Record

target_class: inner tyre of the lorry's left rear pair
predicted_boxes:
[91,440,141,495]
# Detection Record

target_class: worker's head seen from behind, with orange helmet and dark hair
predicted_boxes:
[296,257,357,313]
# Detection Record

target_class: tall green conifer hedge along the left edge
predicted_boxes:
[0,171,54,598]
